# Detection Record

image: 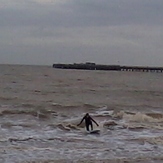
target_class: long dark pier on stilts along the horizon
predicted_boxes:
[53,62,163,73]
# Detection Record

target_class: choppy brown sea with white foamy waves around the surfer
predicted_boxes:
[0,65,163,163]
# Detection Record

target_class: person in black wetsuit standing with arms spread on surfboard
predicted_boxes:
[77,113,99,131]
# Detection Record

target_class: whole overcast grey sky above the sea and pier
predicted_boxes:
[0,0,163,66]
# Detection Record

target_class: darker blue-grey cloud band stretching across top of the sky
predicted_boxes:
[0,0,163,27]
